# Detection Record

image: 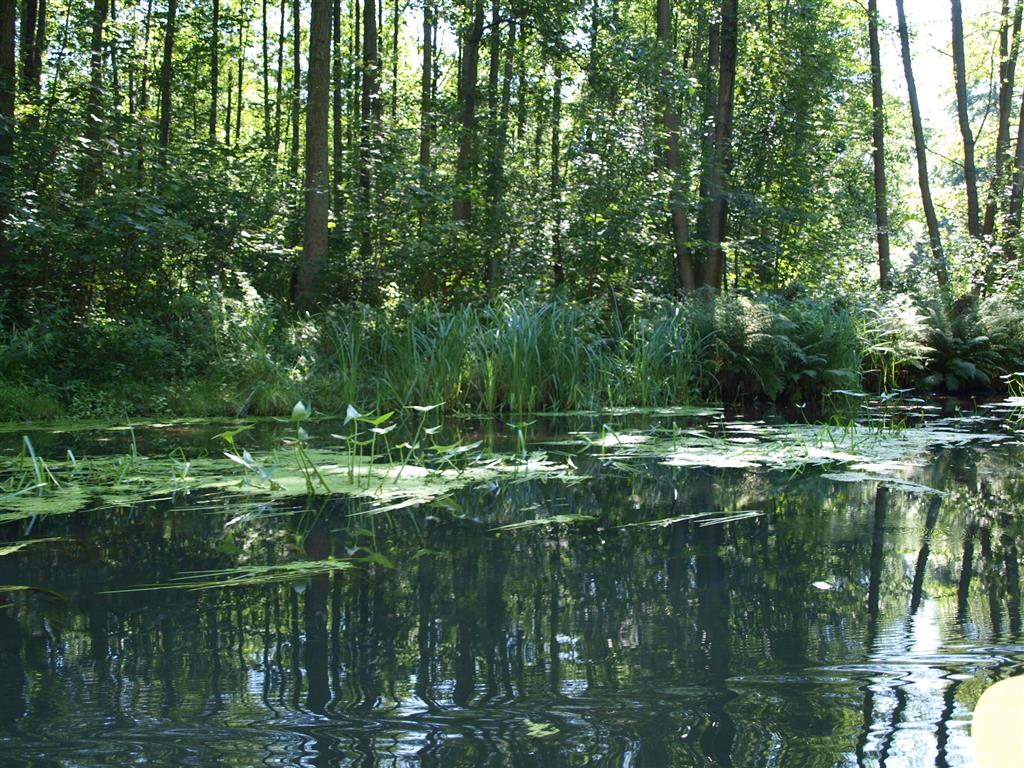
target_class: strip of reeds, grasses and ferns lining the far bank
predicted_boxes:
[0,292,1024,421]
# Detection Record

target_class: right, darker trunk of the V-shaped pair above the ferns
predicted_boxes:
[703,0,738,291]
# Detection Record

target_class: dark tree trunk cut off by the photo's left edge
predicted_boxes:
[0,0,19,305]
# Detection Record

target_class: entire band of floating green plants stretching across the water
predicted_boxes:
[0,418,1018,527]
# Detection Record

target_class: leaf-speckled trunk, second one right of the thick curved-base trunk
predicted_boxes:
[359,0,381,261]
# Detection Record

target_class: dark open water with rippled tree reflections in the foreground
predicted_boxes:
[0,405,1024,768]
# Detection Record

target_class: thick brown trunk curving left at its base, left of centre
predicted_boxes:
[296,0,332,309]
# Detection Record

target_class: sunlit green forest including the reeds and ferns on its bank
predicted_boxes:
[0,0,1024,420]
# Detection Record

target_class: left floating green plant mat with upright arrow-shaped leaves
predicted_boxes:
[0,447,577,523]
